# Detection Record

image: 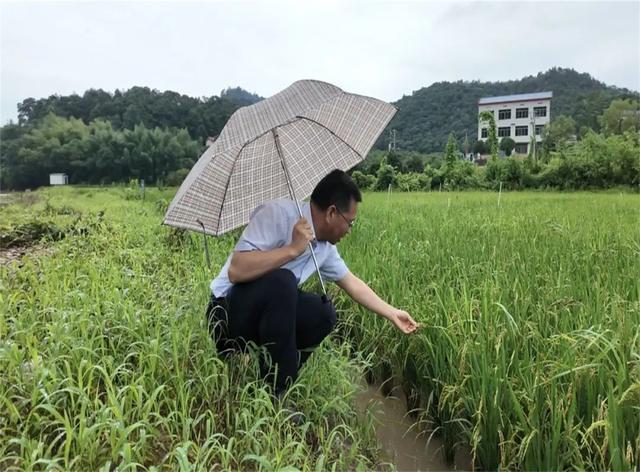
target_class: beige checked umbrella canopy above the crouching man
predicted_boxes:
[164,80,396,236]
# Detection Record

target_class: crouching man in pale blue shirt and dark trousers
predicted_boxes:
[207,170,418,396]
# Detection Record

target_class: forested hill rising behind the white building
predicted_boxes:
[377,68,638,152]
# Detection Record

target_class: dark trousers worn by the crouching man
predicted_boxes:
[207,269,336,393]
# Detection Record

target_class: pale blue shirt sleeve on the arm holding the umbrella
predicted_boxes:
[235,203,286,251]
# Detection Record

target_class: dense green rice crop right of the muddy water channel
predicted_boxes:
[341,193,640,470]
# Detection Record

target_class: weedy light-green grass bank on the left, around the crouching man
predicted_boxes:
[0,189,389,470]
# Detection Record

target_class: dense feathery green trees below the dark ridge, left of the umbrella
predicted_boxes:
[1,114,202,189]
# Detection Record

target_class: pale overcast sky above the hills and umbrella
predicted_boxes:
[0,0,640,124]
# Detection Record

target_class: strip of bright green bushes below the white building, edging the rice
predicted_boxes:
[372,131,640,191]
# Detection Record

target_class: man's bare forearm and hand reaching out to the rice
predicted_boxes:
[336,272,420,334]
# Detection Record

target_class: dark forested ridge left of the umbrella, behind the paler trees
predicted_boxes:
[18,87,262,143]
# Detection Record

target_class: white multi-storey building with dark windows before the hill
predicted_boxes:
[478,92,553,154]
